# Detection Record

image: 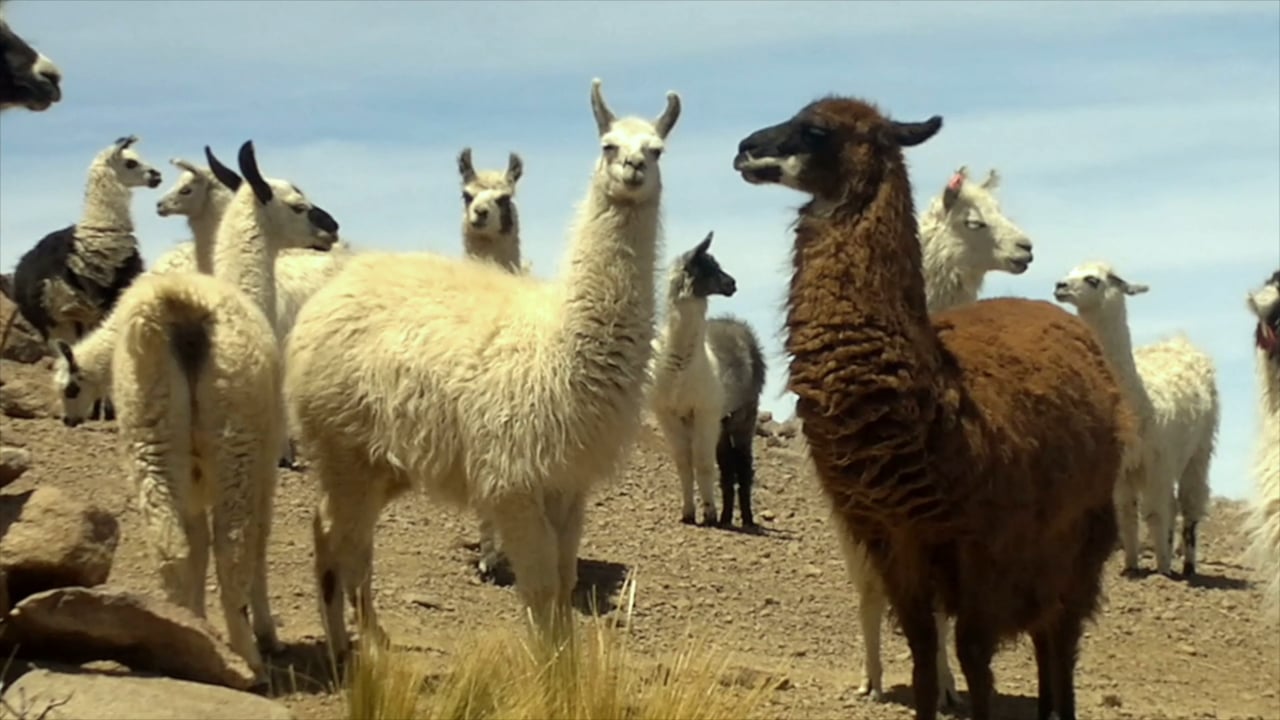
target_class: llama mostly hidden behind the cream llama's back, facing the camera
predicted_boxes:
[458,147,529,582]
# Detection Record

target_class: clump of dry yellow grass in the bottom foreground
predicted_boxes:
[346,578,777,720]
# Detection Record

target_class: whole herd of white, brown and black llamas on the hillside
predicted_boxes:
[0,7,1280,720]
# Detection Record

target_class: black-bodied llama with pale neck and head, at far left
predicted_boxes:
[13,135,160,420]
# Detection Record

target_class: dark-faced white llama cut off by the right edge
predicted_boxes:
[1245,270,1280,623]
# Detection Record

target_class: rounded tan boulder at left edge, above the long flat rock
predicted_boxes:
[0,486,120,602]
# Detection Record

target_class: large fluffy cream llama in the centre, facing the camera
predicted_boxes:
[285,79,680,657]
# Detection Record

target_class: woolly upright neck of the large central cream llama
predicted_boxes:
[563,183,660,389]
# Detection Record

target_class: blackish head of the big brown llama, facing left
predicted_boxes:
[733,96,942,205]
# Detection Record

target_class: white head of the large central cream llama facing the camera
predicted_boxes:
[591,78,680,202]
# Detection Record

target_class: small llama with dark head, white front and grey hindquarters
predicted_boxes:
[649,233,764,528]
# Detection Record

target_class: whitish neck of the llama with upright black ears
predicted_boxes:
[214,191,276,328]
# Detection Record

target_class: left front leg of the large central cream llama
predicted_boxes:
[484,484,561,637]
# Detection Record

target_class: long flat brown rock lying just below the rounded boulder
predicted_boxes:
[9,588,255,691]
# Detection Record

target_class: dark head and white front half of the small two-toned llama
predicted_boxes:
[649,233,737,525]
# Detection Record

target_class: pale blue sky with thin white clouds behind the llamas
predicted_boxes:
[0,0,1280,497]
